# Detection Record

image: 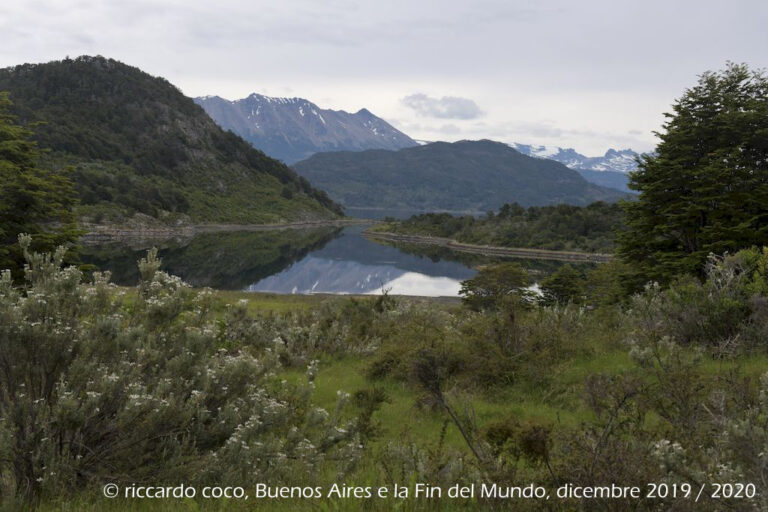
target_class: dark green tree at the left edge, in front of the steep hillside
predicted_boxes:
[0,92,80,279]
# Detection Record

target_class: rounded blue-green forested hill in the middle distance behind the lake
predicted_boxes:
[294,140,624,211]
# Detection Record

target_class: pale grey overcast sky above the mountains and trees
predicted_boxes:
[0,0,768,156]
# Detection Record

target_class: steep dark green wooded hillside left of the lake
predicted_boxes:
[0,57,338,223]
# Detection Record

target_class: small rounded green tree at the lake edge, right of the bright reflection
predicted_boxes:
[459,263,530,311]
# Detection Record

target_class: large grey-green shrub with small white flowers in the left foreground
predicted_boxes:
[0,237,359,497]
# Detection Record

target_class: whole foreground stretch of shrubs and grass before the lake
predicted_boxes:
[0,238,768,510]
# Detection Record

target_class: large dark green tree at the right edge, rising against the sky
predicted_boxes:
[619,63,768,286]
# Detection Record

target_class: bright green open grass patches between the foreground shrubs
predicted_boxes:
[103,291,768,449]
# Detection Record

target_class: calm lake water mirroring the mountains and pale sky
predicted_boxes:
[82,226,584,297]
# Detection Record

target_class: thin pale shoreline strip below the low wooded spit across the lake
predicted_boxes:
[363,230,613,263]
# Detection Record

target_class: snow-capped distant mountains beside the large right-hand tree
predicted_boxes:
[510,143,640,192]
